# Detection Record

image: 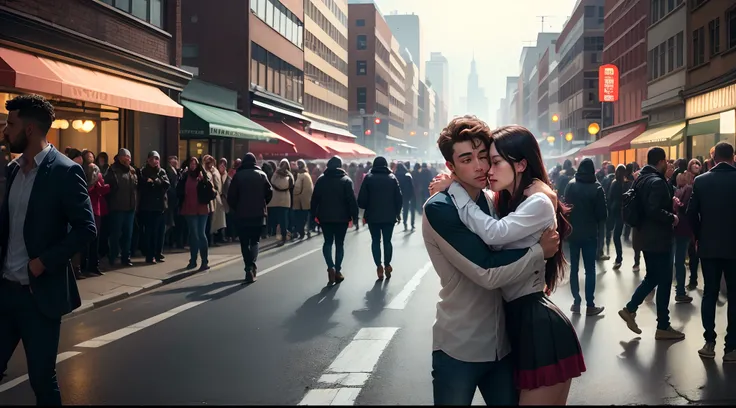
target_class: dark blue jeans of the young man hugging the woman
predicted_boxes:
[432,350,519,406]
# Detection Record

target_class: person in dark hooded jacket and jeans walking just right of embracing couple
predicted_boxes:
[565,159,608,316]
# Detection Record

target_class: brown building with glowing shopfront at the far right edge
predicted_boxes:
[684,0,736,163]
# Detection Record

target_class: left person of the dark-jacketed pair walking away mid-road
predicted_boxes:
[310,156,358,284]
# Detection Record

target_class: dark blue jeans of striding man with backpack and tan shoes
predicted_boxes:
[626,251,672,330]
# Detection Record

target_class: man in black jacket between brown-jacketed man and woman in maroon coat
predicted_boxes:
[138,150,171,264]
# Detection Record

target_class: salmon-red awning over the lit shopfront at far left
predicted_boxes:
[0,47,184,118]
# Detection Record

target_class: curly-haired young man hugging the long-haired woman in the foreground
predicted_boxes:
[422,116,559,405]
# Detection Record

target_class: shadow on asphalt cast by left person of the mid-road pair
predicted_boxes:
[283,284,340,343]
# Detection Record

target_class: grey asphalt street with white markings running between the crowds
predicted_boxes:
[0,222,736,405]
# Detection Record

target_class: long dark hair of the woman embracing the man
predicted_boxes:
[492,125,572,294]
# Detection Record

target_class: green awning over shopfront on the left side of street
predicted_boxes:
[180,100,278,143]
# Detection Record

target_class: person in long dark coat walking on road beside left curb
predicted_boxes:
[227,153,273,283]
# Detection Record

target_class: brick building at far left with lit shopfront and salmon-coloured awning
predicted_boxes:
[0,0,191,165]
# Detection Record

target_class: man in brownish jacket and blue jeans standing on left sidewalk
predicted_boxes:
[105,149,138,266]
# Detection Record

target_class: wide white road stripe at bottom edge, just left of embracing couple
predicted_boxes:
[299,327,399,405]
